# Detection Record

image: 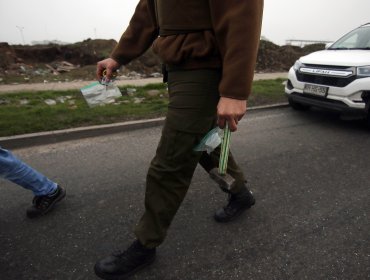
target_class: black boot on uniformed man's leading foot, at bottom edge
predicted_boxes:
[94,240,156,280]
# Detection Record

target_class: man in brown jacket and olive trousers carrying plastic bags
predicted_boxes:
[95,0,263,279]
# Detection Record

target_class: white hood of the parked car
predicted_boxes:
[299,50,370,66]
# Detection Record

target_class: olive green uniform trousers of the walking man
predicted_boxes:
[135,69,246,248]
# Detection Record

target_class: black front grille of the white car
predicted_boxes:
[296,64,357,87]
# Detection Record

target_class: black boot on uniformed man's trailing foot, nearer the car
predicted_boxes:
[214,188,256,223]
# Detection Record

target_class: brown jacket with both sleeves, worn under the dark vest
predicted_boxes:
[111,0,263,100]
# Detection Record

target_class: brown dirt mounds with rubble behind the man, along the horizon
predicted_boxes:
[0,39,324,83]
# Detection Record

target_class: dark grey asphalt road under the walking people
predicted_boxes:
[0,108,370,280]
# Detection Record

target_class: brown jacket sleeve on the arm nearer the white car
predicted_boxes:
[209,0,263,100]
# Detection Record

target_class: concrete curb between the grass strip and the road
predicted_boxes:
[0,103,288,149]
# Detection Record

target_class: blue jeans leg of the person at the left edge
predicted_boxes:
[0,147,57,196]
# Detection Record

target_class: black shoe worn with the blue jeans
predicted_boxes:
[27,186,66,219]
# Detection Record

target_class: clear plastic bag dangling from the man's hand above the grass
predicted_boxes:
[81,82,122,107]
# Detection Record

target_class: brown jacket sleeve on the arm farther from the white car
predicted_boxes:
[110,0,158,65]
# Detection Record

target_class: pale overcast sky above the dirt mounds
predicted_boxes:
[0,0,370,45]
